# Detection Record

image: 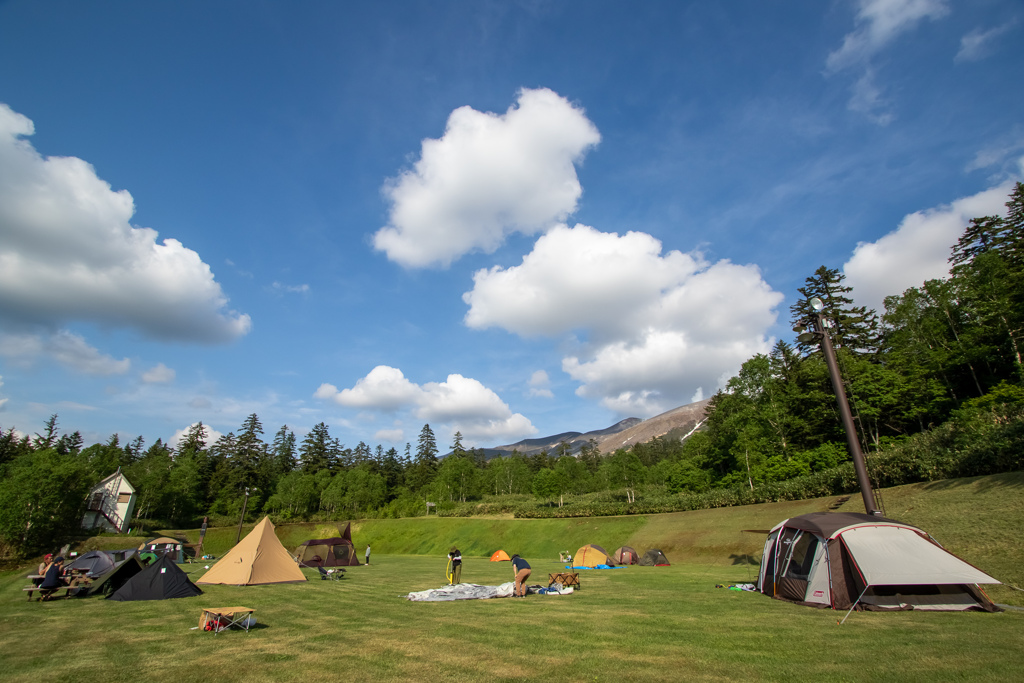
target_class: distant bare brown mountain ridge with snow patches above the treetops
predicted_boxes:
[471,398,711,460]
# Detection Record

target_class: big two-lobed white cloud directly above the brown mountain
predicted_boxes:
[463,225,782,417]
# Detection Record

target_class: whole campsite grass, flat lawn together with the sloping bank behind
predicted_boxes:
[0,474,1024,681]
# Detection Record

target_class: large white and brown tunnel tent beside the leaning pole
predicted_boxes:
[758,512,999,611]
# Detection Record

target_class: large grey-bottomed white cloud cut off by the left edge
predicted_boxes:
[0,103,250,342]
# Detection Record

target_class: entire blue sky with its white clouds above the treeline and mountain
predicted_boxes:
[0,0,1024,451]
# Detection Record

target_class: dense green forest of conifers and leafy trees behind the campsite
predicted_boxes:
[0,183,1024,553]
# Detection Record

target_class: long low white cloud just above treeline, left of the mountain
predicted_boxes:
[313,366,537,445]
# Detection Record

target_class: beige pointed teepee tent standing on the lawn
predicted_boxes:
[196,517,306,586]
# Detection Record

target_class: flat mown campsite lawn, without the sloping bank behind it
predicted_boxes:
[0,555,1024,681]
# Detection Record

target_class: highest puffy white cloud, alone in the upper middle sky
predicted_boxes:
[374,88,601,267]
